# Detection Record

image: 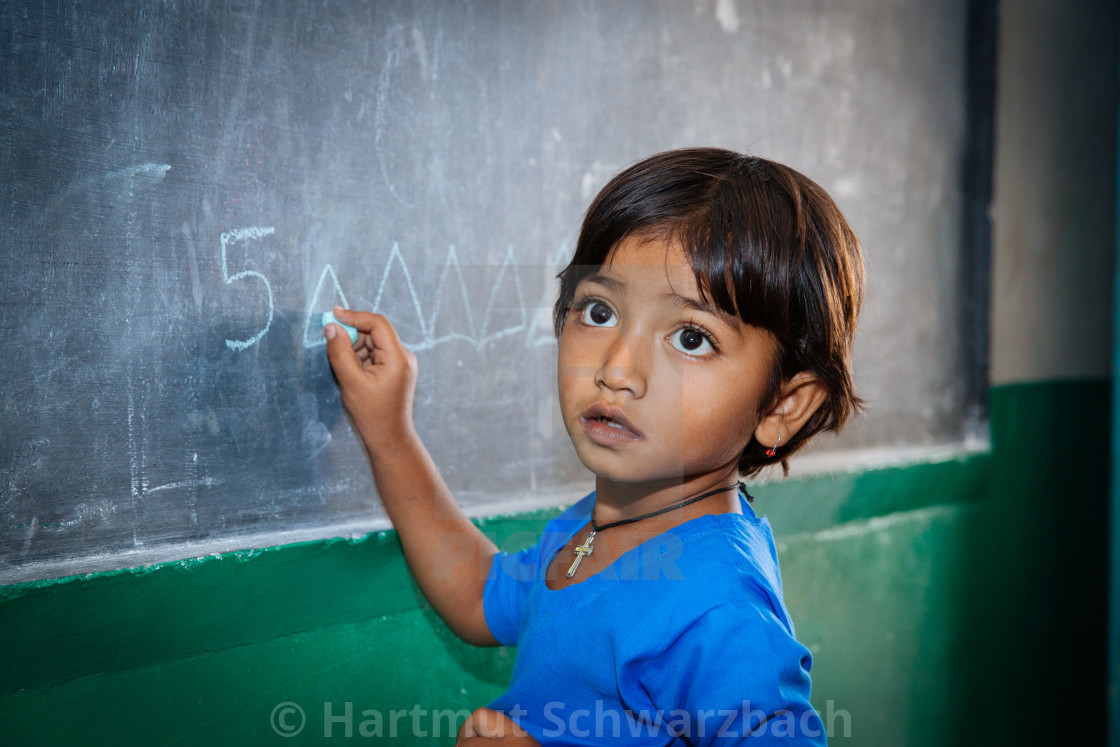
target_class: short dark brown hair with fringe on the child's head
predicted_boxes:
[553,148,864,475]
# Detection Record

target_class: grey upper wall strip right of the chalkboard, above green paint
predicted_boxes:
[991,0,1117,384]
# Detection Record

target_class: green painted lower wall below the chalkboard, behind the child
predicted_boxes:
[0,381,1110,746]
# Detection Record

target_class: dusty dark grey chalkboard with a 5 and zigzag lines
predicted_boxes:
[0,0,967,580]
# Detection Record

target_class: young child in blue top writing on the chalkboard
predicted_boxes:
[326,148,864,746]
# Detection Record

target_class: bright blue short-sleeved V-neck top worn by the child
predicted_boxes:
[483,493,825,745]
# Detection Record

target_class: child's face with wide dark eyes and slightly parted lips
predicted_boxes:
[559,237,776,483]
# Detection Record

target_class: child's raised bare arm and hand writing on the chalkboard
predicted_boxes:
[326,308,497,646]
